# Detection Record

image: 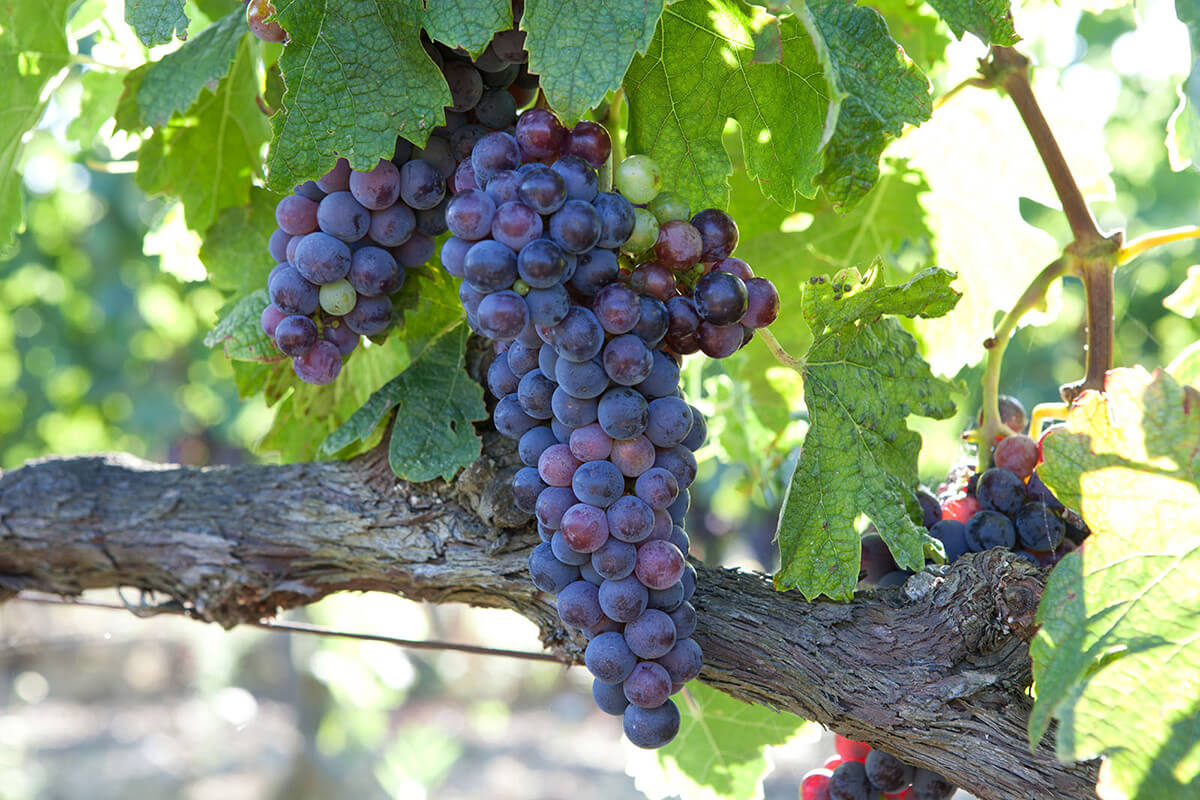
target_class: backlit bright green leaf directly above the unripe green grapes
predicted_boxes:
[625,0,829,210]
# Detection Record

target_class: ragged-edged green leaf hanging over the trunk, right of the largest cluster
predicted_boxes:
[775,264,959,600]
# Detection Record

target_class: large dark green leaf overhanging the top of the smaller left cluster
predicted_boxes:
[268,0,450,191]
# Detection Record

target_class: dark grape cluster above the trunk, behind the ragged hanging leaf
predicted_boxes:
[860,396,1088,587]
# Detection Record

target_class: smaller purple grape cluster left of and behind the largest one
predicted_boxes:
[262,35,536,385]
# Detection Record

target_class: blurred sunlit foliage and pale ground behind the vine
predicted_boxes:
[0,0,1200,800]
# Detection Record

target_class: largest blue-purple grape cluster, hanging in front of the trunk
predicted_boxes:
[442,108,779,747]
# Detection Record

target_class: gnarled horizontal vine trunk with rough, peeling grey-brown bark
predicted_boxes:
[0,448,1096,800]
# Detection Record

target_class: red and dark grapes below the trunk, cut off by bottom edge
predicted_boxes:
[800,735,958,800]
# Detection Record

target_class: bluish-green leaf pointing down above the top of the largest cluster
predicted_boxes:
[521,0,662,124]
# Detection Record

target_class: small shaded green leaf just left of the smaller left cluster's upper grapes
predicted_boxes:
[200,186,280,296]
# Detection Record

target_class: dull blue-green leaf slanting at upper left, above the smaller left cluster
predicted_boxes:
[137,7,247,127]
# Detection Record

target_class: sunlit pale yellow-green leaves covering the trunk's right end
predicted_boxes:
[1030,367,1200,800]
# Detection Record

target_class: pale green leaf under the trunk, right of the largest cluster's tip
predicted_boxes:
[626,680,806,800]
